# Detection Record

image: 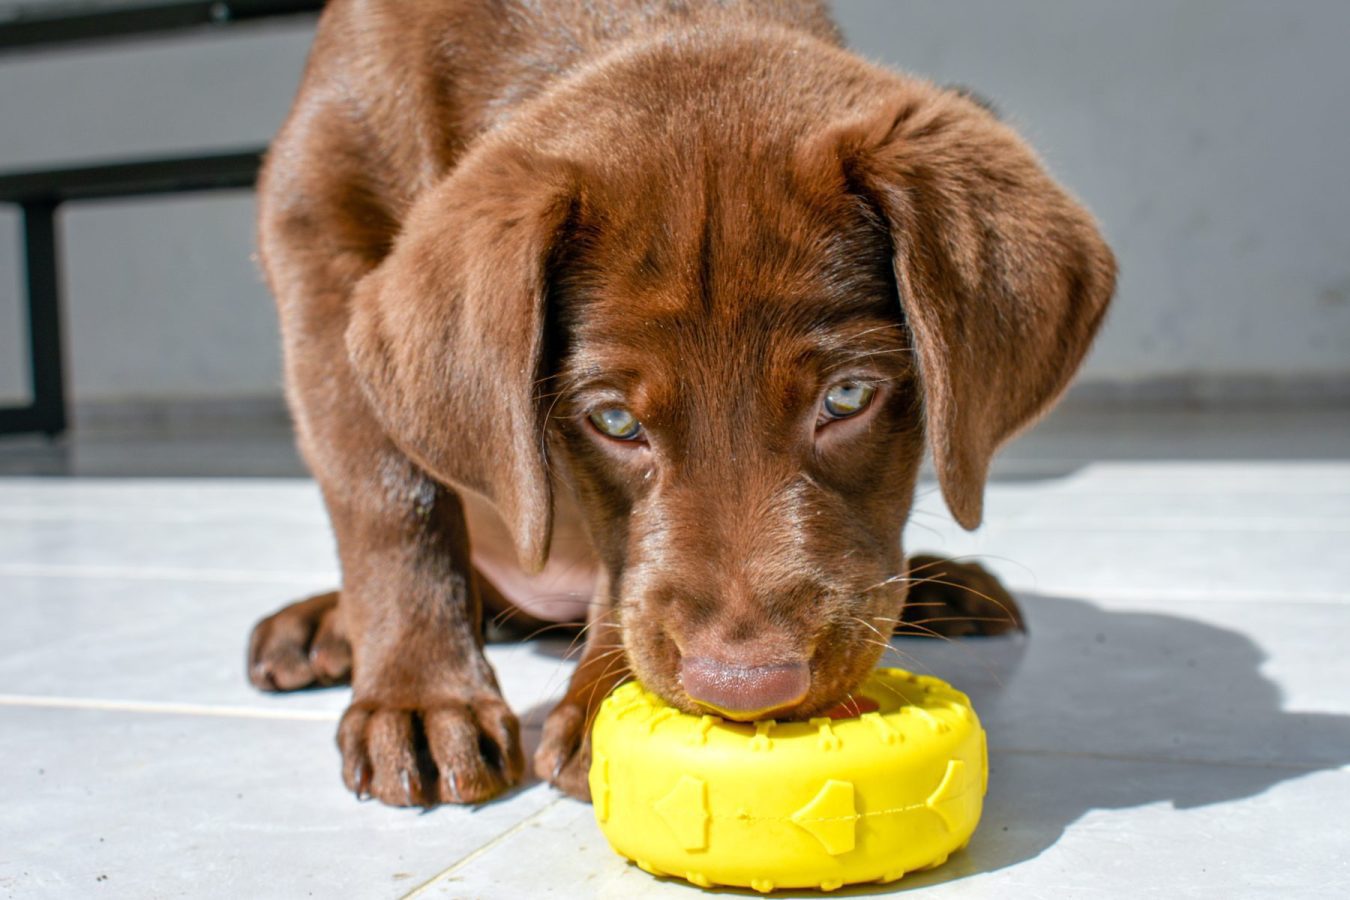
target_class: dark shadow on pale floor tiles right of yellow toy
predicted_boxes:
[521,594,1350,896]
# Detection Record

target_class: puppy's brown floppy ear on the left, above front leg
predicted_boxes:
[347,146,576,571]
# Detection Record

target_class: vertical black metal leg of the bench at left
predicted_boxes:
[23,201,66,436]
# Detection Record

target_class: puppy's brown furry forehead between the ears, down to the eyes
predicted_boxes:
[548,146,900,418]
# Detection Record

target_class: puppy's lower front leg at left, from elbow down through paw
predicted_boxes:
[325,456,524,806]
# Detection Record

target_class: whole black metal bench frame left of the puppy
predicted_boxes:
[0,0,324,436]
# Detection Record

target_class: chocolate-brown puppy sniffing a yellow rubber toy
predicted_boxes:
[250,0,1115,804]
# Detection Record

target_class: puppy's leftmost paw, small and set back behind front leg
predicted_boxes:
[248,591,351,691]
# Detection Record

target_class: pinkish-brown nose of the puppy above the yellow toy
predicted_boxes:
[679,656,811,722]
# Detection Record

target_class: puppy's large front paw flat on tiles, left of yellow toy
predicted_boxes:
[338,695,525,807]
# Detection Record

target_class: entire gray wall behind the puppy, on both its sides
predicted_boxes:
[0,0,1350,401]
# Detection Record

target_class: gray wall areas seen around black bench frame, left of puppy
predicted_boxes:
[0,22,311,402]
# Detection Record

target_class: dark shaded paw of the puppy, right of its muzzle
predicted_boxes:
[895,556,1026,637]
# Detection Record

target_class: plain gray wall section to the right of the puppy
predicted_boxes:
[837,0,1350,394]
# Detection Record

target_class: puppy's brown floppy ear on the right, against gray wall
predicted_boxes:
[834,85,1115,529]
